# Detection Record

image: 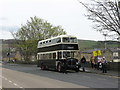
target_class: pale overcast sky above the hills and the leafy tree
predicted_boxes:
[0,0,107,41]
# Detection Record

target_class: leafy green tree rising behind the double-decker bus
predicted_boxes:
[12,16,66,60]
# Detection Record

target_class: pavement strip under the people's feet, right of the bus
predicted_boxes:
[80,67,120,78]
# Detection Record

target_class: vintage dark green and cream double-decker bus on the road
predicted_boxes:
[37,35,79,72]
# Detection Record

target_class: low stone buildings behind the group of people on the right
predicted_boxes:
[81,48,120,62]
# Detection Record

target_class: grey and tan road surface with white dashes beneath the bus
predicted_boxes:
[0,64,118,89]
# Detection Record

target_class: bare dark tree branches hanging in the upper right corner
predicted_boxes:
[79,0,120,37]
